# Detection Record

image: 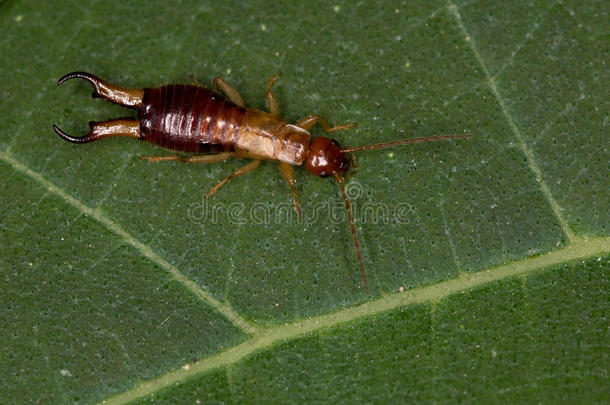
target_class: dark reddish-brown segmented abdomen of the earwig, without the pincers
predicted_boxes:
[138,84,246,153]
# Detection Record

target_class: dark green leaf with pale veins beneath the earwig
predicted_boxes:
[0,1,610,403]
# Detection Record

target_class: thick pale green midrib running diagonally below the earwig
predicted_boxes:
[102,237,610,404]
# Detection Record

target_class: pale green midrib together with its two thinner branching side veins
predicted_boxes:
[0,0,610,403]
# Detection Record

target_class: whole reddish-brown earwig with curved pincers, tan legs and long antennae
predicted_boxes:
[53,72,471,293]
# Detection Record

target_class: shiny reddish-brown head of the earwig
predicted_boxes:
[305,136,350,177]
